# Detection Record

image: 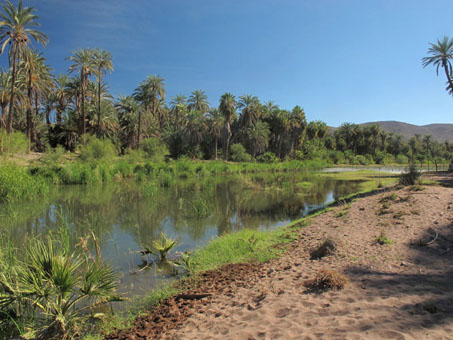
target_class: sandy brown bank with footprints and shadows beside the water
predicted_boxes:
[107,177,453,340]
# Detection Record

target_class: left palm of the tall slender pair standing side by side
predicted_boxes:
[69,48,95,135]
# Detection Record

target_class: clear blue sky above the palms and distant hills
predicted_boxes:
[0,0,453,126]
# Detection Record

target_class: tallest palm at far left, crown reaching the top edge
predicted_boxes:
[0,0,48,135]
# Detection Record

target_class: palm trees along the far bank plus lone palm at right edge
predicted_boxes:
[0,1,453,164]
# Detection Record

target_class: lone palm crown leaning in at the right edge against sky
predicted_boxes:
[422,37,453,95]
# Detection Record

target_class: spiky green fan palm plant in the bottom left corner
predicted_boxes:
[0,238,121,339]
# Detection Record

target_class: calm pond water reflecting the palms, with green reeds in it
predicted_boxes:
[0,174,359,296]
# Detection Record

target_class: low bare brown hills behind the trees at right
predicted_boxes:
[329,121,453,142]
